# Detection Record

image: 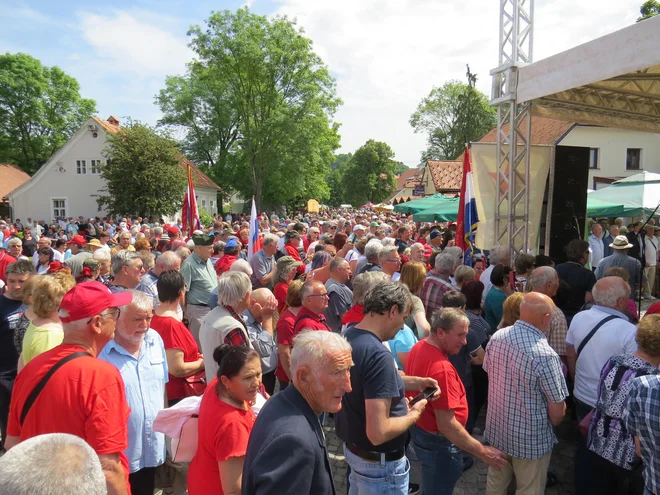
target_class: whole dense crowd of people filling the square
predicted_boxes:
[0,210,660,495]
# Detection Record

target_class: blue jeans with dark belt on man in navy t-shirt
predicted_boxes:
[344,444,410,495]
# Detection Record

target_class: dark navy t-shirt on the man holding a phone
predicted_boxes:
[335,327,408,452]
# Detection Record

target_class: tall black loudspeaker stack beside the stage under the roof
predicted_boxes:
[548,146,589,264]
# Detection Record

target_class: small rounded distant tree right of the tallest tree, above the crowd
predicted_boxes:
[342,139,396,206]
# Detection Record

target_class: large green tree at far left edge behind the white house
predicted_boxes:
[0,53,96,174]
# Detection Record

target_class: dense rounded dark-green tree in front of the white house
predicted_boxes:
[96,121,188,217]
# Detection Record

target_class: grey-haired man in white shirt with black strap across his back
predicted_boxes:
[566,277,637,421]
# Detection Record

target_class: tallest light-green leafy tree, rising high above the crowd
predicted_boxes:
[184,8,341,208]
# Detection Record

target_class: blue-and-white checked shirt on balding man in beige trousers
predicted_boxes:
[483,320,568,459]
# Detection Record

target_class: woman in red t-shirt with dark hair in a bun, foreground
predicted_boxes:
[188,344,261,495]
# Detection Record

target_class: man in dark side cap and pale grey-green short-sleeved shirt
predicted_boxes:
[181,234,218,346]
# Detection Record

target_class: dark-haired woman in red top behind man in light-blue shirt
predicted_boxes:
[151,270,204,407]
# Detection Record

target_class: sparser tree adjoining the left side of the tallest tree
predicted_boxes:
[156,62,240,196]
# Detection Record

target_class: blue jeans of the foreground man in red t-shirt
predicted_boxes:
[410,425,463,495]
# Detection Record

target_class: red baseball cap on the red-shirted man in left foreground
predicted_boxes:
[60,282,133,323]
